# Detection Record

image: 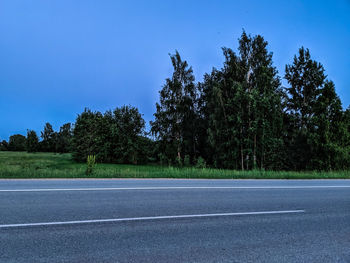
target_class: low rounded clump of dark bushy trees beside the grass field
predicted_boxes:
[72,106,151,164]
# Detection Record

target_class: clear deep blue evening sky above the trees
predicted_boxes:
[0,0,350,140]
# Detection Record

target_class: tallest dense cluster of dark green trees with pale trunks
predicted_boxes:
[200,32,282,170]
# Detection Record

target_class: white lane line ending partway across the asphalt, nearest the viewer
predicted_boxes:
[0,210,305,229]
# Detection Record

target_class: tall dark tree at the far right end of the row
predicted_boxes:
[285,47,349,170]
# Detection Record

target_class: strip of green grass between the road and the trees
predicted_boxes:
[0,152,350,179]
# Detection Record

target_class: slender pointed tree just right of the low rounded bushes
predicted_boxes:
[151,51,198,164]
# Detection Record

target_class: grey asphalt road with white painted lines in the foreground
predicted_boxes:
[0,179,350,263]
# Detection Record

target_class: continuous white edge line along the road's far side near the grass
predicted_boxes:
[0,185,350,192]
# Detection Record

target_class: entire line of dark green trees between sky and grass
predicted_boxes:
[1,31,350,170]
